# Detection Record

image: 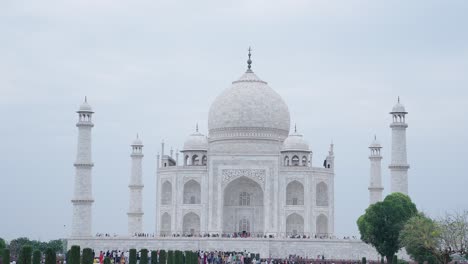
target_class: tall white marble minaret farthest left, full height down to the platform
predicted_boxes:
[71,97,94,237]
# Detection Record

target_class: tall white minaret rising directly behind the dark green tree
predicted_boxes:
[388,97,409,195]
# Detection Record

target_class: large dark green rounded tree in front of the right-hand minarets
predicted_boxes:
[357,193,417,263]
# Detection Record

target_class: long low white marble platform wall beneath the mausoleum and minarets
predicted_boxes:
[67,237,409,260]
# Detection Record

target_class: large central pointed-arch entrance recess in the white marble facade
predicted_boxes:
[223,177,264,235]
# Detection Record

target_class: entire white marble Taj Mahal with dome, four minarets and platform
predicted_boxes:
[68,50,409,259]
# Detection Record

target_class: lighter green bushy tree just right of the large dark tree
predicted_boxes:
[400,213,441,264]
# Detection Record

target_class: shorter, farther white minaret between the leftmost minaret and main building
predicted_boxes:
[127,134,144,235]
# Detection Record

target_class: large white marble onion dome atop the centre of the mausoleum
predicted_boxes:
[208,70,290,141]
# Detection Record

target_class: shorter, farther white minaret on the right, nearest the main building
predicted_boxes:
[369,137,383,205]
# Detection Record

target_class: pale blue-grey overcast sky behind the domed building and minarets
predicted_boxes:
[0,0,468,240]
